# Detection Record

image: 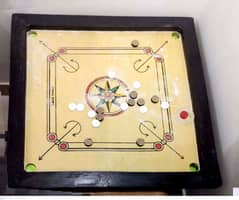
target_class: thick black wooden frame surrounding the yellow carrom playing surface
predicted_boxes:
[7,14,221,190]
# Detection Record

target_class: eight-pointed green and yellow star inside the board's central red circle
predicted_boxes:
[95,80,126,112]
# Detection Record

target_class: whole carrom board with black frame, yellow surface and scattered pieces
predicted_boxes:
[8,15,220,188]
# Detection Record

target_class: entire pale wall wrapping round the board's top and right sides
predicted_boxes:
[0,0,239,194]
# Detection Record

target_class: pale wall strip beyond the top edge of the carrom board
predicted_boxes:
[0,0,207,81]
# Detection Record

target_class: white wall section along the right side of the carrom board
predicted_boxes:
[190,0,239,194]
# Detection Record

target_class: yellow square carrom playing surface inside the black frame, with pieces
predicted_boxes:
[24,30,200,172]
